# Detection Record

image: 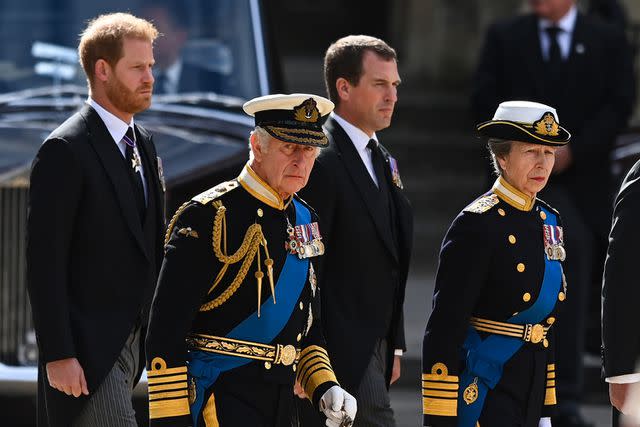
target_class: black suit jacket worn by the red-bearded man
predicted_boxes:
[27,105,164,426]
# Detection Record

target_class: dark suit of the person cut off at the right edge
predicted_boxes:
[602,162,640,426]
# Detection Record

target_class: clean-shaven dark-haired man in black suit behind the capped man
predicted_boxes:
[302,36,413,426]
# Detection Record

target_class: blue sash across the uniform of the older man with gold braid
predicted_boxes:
[188,199,311,426]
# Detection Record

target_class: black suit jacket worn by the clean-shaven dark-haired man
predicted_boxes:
[301,118,413,394]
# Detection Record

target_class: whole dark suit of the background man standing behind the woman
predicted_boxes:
[472,0,634,426]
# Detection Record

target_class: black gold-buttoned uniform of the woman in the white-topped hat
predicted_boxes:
[422,178,566,427]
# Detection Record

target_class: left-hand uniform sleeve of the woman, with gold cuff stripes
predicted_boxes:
[422,212,492,427]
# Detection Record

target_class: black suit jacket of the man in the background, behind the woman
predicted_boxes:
[472,12,635,238]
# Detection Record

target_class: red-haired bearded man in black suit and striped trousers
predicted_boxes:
[27,13,164,427]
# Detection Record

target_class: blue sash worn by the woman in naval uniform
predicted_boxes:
[458,208,562,427]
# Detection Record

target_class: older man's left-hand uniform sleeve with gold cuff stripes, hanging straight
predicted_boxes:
[146,203,217,427]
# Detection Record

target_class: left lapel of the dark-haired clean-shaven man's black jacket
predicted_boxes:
[325,118,398,260]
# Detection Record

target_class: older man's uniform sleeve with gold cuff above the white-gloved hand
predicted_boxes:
[296,258,339,408]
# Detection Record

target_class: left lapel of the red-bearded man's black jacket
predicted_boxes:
[80,105,150,259]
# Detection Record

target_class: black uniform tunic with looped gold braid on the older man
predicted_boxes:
[147,166,337,426]
